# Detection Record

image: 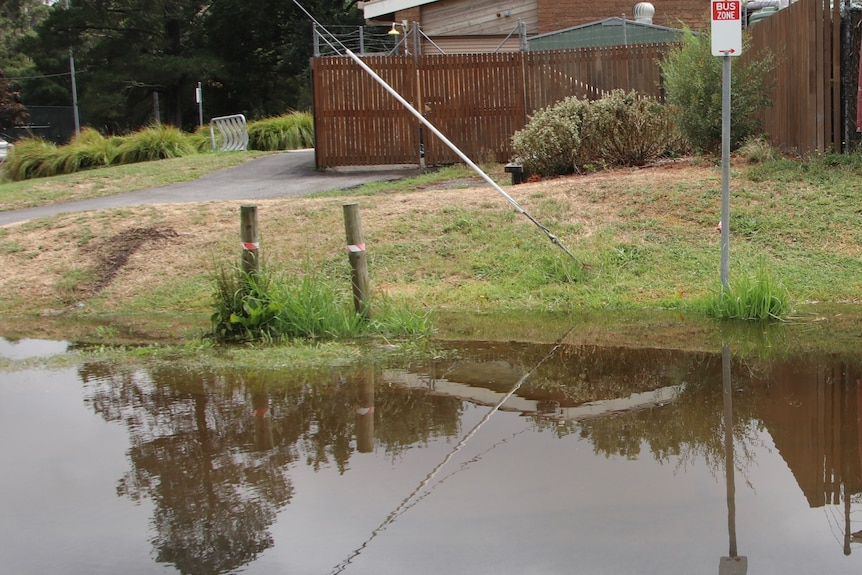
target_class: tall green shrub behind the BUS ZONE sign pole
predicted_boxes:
[660,30,777,152]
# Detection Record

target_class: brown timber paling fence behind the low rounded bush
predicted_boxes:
[313,44,669,168]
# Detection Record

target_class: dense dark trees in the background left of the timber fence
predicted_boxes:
[0,0,362,133]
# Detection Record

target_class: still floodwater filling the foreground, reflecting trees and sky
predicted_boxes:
[0,328,862,575]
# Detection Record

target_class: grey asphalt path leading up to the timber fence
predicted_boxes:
[0,150,419,226]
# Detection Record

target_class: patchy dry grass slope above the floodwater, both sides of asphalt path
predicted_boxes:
[0,151,862,348]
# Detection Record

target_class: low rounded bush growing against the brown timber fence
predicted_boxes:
[512,90,685,176]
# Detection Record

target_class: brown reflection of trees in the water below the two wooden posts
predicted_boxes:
[79,364,462,574]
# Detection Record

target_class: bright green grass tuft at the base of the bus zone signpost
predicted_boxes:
[705,262,791,320]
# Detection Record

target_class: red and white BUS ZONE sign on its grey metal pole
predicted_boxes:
[710,0,742,288]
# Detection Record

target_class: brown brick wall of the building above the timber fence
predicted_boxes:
[537,0,710,34]
